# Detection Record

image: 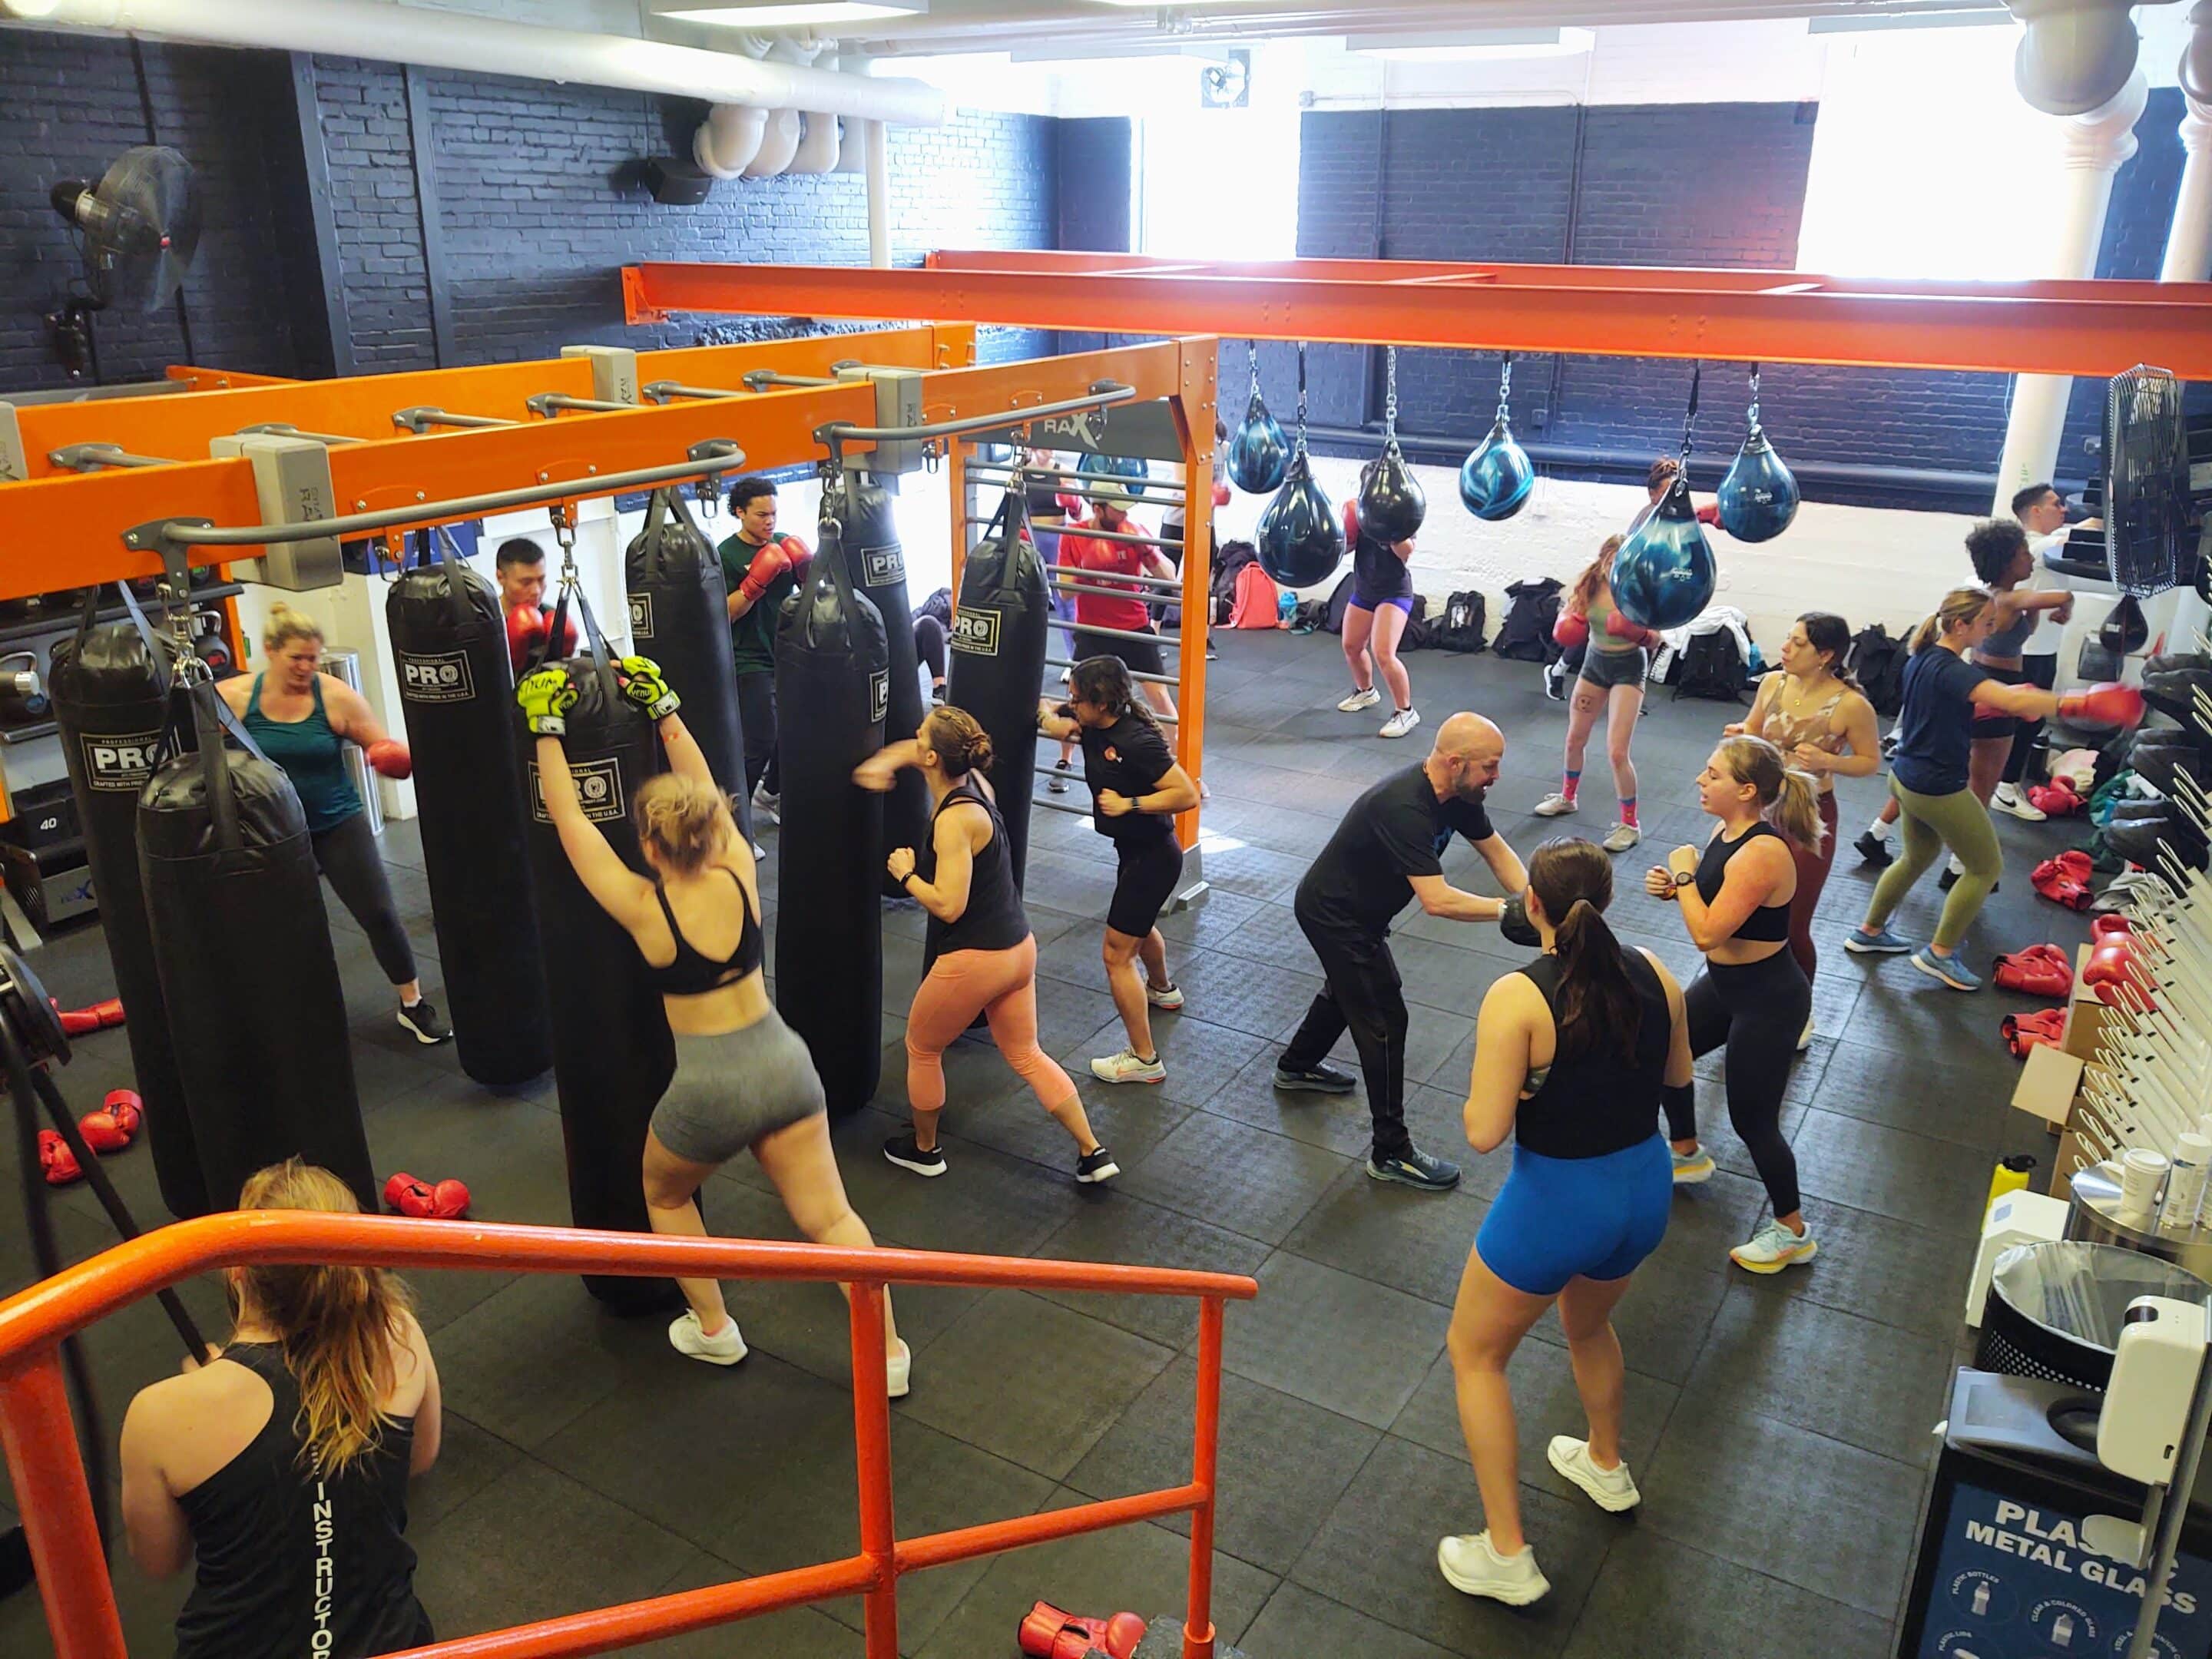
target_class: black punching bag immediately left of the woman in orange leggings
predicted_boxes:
[774,520,889,1117]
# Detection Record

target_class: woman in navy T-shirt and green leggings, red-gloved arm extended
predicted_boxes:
[1843,588,2144,991]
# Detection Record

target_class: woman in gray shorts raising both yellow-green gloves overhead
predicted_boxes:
[515,657,913,1398]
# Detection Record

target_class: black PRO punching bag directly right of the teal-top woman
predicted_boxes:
[385,531,553,1086]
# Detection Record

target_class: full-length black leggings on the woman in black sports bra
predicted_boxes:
[1666,947,1812,1214]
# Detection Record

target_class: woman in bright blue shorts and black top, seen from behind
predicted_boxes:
[1435,840,1692,1606]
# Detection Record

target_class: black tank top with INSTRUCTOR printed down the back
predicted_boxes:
[177,1343,432,1659]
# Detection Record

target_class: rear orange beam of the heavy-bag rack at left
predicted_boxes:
[15,325,975,478]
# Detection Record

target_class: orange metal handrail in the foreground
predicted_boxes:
[0,1210,1259,1659]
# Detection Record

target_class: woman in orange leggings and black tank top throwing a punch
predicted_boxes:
[854,704,1121,1184]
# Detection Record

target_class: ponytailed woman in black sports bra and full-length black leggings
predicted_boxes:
[1644,737,1825,1274]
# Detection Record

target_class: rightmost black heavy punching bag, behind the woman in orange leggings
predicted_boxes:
[947,491,1051,885]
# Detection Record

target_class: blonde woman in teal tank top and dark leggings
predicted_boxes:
[217,604,453,1041]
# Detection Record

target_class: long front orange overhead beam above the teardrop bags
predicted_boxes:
[624,254,2212,380]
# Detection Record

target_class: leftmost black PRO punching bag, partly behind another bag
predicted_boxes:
[46,586,212,1221]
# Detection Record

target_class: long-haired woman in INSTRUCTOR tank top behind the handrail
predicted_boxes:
[121,1159,440,1659]
